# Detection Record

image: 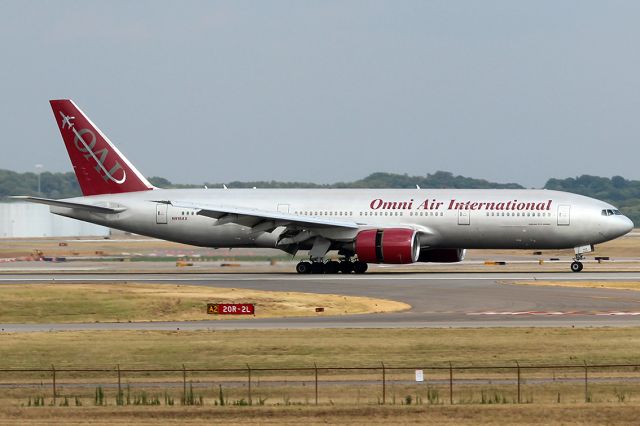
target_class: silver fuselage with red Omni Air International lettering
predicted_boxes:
[51,189,633,249]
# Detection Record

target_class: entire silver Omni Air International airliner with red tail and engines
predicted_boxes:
[19,100,633,273]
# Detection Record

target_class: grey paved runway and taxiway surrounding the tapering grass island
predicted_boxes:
[0,272,640,332]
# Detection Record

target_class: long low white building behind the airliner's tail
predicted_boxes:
[0,202,110,238]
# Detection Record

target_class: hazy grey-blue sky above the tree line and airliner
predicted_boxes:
[0,0,640,186]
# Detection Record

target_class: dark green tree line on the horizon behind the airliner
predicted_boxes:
[0,169,640,224]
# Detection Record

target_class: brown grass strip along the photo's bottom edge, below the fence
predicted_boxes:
[0,404,639,425]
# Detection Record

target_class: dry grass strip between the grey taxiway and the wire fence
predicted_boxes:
[0,328,640,368]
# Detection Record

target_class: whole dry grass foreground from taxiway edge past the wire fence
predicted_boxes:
[0,328,640,424]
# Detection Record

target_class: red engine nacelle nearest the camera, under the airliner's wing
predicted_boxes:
[355,228,420,263]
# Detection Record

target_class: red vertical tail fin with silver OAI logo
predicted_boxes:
[50,99,153,195]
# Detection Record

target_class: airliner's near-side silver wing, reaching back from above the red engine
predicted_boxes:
[165,201,361,230]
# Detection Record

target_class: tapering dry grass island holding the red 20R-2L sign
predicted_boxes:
[0,283,410,323]
